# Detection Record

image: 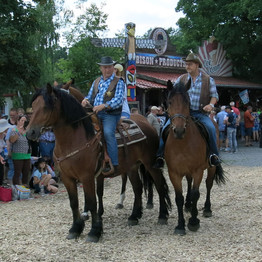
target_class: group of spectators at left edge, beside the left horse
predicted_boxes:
[0,108,58,194]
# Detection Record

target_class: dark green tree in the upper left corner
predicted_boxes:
[0,0,40,92]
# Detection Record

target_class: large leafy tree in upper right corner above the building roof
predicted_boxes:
[173,0,262,82]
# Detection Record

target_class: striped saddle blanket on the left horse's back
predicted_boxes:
[115,119,146,147]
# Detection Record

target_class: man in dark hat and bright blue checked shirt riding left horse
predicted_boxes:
[82,56,125,175]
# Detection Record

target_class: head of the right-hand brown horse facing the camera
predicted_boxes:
[167,80,191,139]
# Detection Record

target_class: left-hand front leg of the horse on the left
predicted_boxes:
[62,175,85,239]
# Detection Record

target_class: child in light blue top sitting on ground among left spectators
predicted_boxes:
[32,158,58,194]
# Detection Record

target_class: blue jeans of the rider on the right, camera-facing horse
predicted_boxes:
[157,111,219,156]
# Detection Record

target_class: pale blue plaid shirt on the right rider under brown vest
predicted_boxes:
[175,72,218,110]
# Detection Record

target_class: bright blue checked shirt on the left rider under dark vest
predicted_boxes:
[85,74,125,109]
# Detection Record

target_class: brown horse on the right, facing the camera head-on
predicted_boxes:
[165,81,225,235]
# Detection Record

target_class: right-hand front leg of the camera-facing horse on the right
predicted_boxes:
[187,170,203,231]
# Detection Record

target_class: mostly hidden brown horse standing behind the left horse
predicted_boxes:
[60,79,156,210]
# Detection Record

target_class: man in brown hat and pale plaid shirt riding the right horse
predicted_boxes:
[154,53,221,168]
